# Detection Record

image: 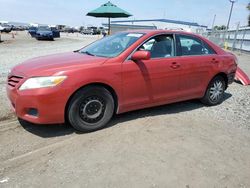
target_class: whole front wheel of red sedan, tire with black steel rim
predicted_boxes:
[67,86,114,132]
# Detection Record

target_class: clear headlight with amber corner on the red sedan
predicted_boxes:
[19,76,67,90]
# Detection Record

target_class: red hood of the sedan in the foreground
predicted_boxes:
[11,52,107,77]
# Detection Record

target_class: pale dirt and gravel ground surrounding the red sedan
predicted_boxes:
[0,30,250,188]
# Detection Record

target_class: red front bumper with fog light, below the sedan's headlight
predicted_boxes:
[6,86,70,124]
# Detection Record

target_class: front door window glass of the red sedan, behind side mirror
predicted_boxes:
[139,35,174,58]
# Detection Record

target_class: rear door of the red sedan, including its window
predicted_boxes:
[176,35,218,99]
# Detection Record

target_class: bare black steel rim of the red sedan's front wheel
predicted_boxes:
[79,97,105,123]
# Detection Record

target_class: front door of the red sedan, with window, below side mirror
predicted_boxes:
[122,35,180,110]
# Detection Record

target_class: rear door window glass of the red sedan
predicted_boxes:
[178,35,215,56]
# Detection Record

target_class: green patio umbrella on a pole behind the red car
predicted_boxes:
[87,2,132,34]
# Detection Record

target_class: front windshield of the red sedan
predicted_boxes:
[79,33,143,57]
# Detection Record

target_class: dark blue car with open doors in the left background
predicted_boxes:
[34,26,60,40]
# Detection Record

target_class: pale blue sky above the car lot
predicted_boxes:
[0,0,249,27]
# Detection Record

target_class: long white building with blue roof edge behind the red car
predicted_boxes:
[103,19,207,33]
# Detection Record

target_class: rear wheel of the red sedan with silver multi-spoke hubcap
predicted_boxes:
[201,76,226,106]
